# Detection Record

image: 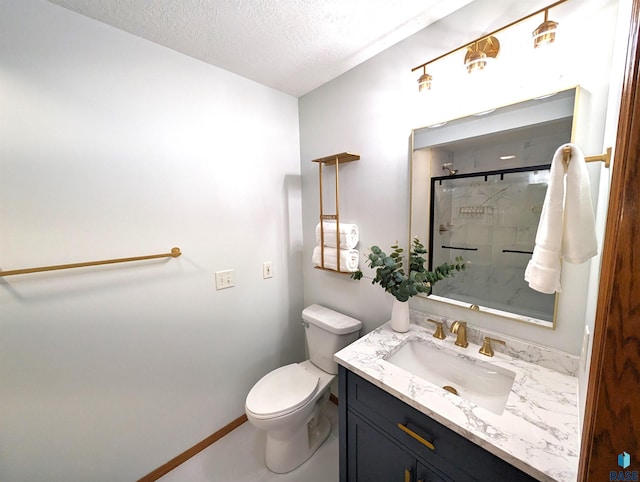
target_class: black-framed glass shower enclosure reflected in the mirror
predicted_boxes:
[429,168,555,322]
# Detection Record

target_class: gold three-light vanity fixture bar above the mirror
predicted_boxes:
[411,0,567,92]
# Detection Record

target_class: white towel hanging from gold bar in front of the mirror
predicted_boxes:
[524,144,598,294]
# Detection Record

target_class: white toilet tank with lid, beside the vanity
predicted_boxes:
[302,305,362,374]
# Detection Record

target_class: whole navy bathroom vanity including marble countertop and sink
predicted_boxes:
[335,323,578,482]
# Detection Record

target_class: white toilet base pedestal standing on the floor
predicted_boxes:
[265,416,331,474]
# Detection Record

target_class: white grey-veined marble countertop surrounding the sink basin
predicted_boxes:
[335,323,579,481]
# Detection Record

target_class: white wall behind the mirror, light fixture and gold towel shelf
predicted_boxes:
[300,0,628,355]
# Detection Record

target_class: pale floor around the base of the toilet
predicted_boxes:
[158,403,339,482]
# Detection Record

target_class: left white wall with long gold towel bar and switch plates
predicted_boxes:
[0,0,304,482]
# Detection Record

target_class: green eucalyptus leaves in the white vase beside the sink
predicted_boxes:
[351,238,467,301]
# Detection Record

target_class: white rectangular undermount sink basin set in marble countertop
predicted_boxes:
[385,340,516,415]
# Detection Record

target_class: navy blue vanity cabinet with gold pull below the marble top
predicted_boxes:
[339,366,536,482]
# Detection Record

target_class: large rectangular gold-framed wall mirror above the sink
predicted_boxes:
[410,88,578,328]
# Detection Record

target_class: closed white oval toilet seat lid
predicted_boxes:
[246,363,319,417]
